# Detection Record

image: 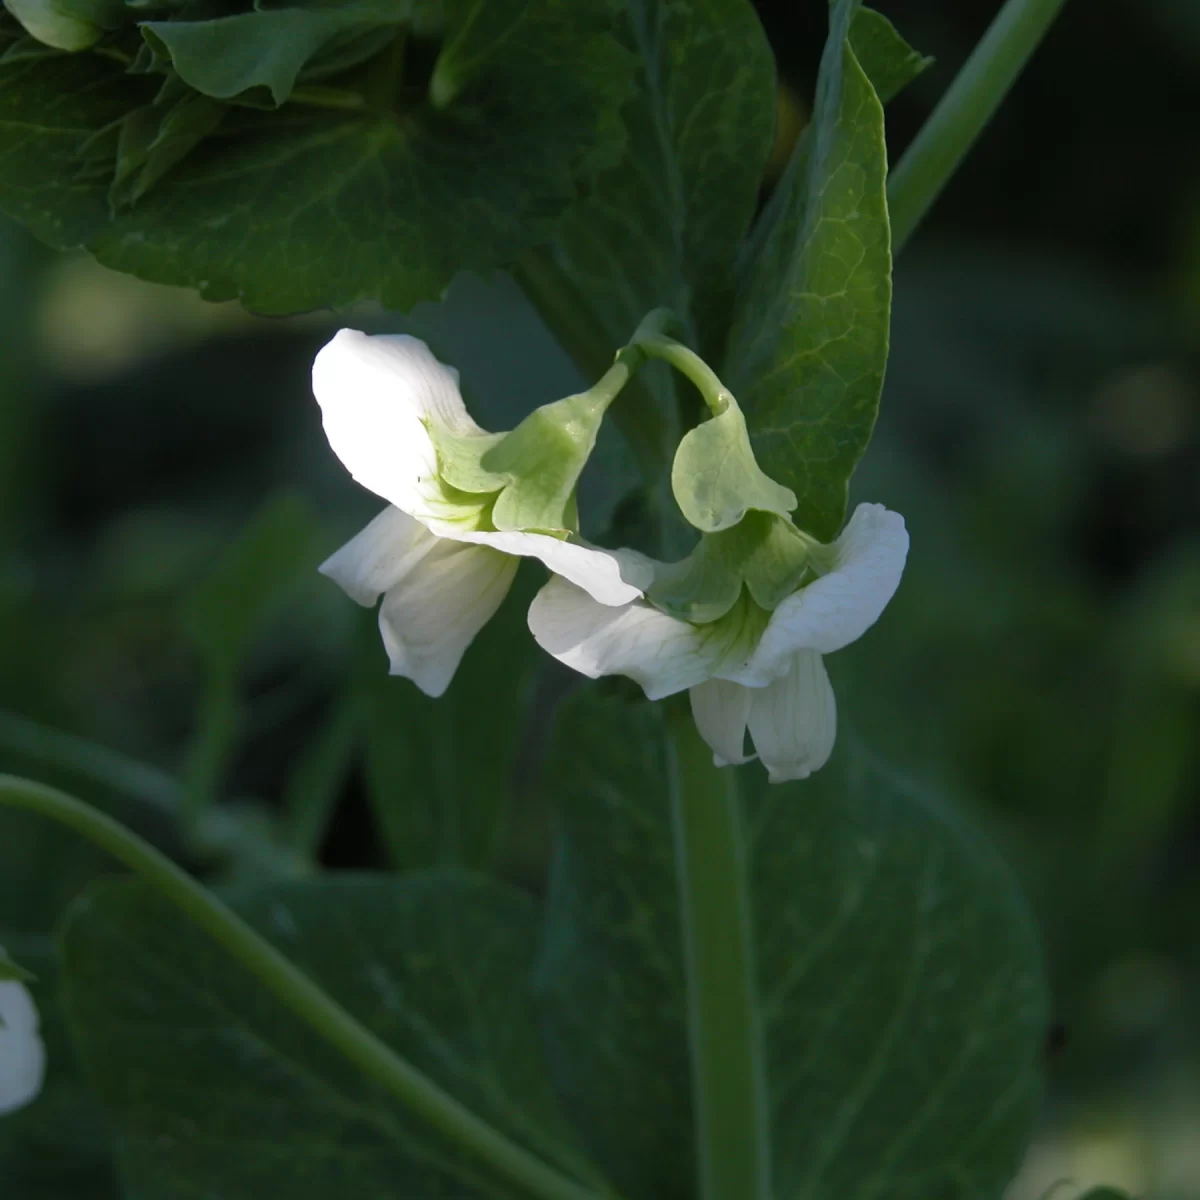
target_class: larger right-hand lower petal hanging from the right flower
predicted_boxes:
[750,650,838,784]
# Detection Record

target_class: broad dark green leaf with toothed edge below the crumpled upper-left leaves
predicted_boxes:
[0,0,634,312]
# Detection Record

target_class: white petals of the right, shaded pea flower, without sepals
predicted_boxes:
[529,504,908,784]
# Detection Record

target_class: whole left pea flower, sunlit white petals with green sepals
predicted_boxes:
[312,329,650,696]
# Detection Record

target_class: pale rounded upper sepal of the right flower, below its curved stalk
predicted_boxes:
[671,392,796,533]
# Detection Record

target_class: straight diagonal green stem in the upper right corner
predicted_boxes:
[888,0,1064,253]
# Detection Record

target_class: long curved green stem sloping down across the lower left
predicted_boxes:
[0,775,596,1200]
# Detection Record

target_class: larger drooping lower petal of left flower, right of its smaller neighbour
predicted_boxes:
[379,535,517,696]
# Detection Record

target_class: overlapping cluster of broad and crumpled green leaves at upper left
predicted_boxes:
[0,0,634,312]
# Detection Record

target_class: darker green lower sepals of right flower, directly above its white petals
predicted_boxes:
[649,512,811,624]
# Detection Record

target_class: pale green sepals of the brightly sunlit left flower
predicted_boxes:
[430,390,613,532]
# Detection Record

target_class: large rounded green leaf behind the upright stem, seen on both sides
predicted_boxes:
[538,690,1045,1200]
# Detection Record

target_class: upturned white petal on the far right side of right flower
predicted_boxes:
[732,504,908,686]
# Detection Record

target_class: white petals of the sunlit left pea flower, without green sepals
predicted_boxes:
[312,329,652,696]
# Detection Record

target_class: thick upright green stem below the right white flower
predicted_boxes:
[670,702,770,1200]
